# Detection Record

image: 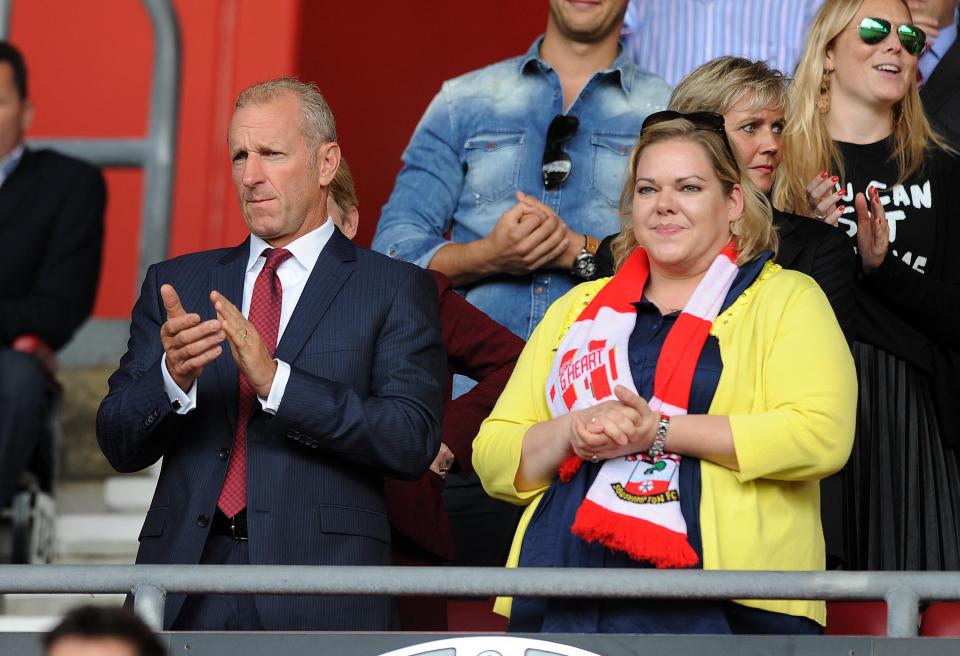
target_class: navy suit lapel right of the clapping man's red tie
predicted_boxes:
[275,229,356,363]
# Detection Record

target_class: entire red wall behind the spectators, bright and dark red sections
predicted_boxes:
[10,0,546,318]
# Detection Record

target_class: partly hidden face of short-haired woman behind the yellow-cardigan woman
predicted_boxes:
[723,94,783,194]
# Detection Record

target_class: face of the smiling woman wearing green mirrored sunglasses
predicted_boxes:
[823,0,917,108]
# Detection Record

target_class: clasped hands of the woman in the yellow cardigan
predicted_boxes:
[570,385,660,462]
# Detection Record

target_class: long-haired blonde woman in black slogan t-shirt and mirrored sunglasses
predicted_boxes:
[774,0,960,570]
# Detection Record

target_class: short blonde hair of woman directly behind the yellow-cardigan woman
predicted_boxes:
[667,56,787,114]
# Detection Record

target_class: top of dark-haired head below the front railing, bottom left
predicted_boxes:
[43,606,166,656]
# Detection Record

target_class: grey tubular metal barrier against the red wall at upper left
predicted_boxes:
[0,0,180,366]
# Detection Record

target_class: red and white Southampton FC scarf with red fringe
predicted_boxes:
[546,242,738,567]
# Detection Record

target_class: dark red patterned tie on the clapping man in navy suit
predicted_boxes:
[217,248,291,517]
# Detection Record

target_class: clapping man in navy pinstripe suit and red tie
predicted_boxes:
[97,78,445,630]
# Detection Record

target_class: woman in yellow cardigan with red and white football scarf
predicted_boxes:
[473,112,856,633]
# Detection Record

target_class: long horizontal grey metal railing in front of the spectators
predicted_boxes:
[0,565,960,638]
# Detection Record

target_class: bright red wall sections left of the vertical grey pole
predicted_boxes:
[10,0,153,316]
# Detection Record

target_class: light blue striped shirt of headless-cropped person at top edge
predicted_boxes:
[624,0,823,86]
